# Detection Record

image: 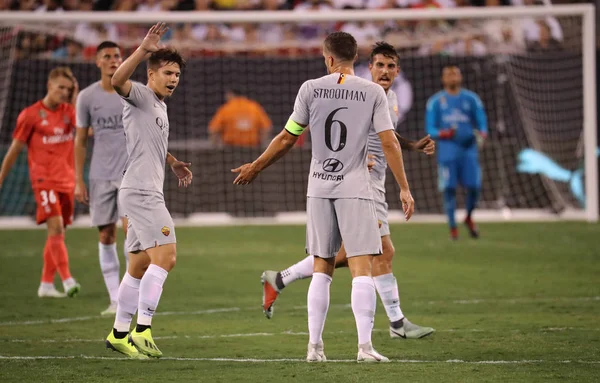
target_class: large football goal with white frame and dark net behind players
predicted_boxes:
[0,5,598,228]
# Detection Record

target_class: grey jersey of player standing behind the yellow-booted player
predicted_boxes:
[76,82,127,181]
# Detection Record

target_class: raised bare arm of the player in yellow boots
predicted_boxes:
[110,23,169,97]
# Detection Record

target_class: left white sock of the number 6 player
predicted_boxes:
[307,273,331,344]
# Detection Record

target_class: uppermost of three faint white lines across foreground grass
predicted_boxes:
[0,296,600,326]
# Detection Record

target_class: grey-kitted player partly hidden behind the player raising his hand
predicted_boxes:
[75,41,127,315]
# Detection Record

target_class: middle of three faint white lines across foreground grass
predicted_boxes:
[0,327,600,343]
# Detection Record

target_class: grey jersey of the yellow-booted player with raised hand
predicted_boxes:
[121,82,169,194]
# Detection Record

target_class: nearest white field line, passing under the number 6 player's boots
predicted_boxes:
[0,355,600,364]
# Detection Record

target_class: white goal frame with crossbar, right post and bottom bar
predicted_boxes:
[0,4,599,226]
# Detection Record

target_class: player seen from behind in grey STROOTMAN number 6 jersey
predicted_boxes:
[232,32,414,362]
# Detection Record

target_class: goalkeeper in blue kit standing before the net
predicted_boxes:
[425,65,488,239]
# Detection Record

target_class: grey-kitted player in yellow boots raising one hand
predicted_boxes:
[106,23,192,358]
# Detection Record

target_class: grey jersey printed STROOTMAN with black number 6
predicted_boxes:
[290,73,394,199]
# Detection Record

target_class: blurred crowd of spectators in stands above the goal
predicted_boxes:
[0,0,592,60]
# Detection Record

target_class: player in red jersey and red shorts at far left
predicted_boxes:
[0,67,81,298]
